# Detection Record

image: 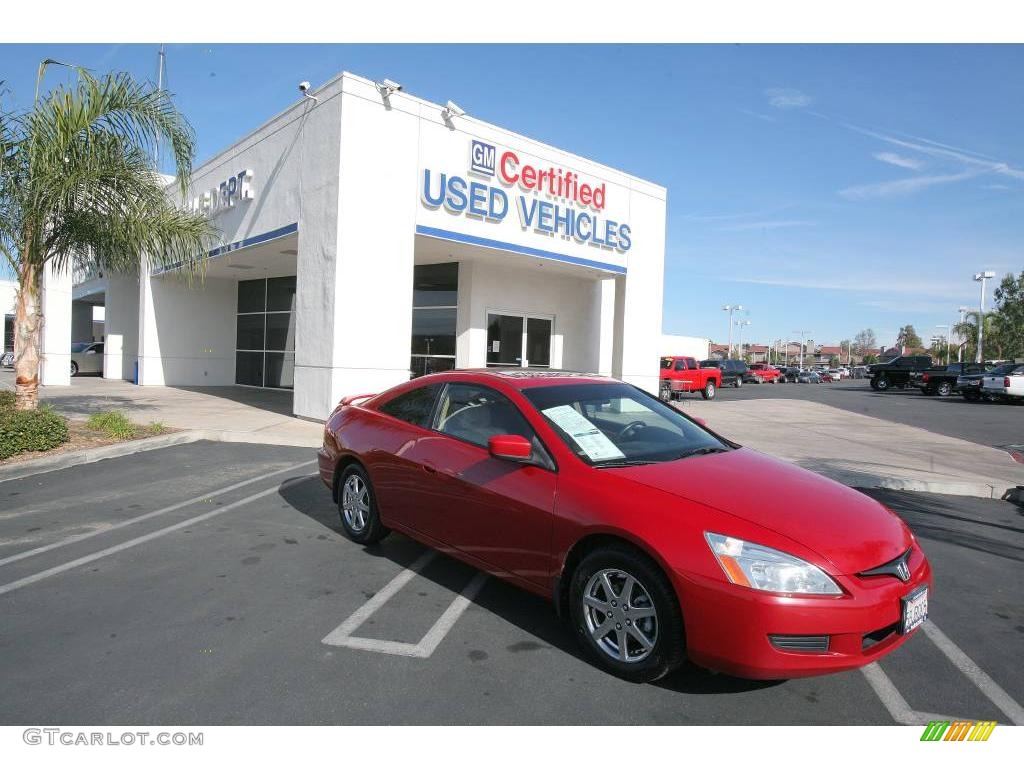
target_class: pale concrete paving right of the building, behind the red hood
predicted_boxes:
[677,398,1024,499]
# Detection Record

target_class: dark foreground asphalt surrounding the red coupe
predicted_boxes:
[0,442,1024,725]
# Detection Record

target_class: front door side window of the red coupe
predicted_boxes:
[436,384,536,447]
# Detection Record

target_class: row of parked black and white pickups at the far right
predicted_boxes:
[870,354,1024,402]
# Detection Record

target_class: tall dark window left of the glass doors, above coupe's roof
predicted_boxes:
[411,263,459,378]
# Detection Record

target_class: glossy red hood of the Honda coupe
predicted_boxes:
[614,449,911,573]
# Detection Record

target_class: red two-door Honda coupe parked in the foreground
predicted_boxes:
[319,370,932,681]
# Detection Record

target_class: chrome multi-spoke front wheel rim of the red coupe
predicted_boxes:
[583,568,658,664]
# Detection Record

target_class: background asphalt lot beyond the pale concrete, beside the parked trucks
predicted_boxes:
[681,379,1024,447]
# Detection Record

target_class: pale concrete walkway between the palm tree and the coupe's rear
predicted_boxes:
[0,371,324,447]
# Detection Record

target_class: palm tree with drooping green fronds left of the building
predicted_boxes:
[0,67,214,410]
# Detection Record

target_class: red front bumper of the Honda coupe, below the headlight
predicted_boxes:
[673,546,932,680]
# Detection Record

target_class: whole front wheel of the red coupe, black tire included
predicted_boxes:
[568,545,686,683]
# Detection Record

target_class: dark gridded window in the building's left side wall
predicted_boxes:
[234,276,295,389]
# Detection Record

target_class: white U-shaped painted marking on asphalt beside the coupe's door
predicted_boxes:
[321,550,487,658]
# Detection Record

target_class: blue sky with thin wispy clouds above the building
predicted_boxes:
[0,44,1024,350]
